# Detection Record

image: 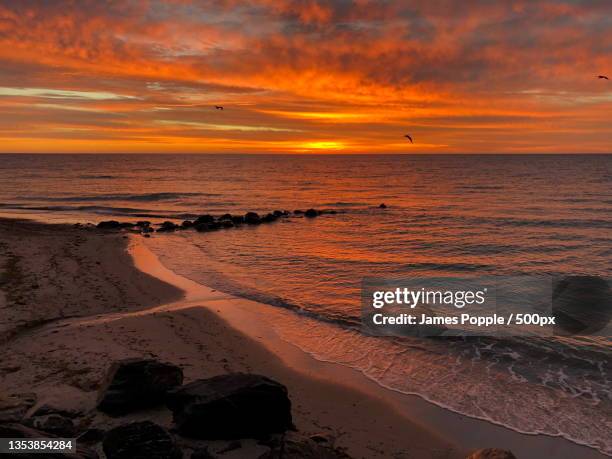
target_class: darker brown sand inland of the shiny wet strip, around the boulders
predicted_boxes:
[0,220,464,458]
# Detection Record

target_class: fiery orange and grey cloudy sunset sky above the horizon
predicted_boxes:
[0,0,612,153]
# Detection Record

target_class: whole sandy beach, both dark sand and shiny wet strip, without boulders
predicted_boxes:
[0,220,599,458]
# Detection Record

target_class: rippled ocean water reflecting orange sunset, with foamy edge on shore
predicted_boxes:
[0,155,612,455]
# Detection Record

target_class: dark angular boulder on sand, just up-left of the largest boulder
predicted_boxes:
[98,359,183,415]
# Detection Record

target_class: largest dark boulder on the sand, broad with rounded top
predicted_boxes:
[167,373,292,439]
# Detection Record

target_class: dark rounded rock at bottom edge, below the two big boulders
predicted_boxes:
[102,421,183,459]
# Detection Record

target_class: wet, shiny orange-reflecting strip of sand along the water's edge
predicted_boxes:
[130,237,608,459]
